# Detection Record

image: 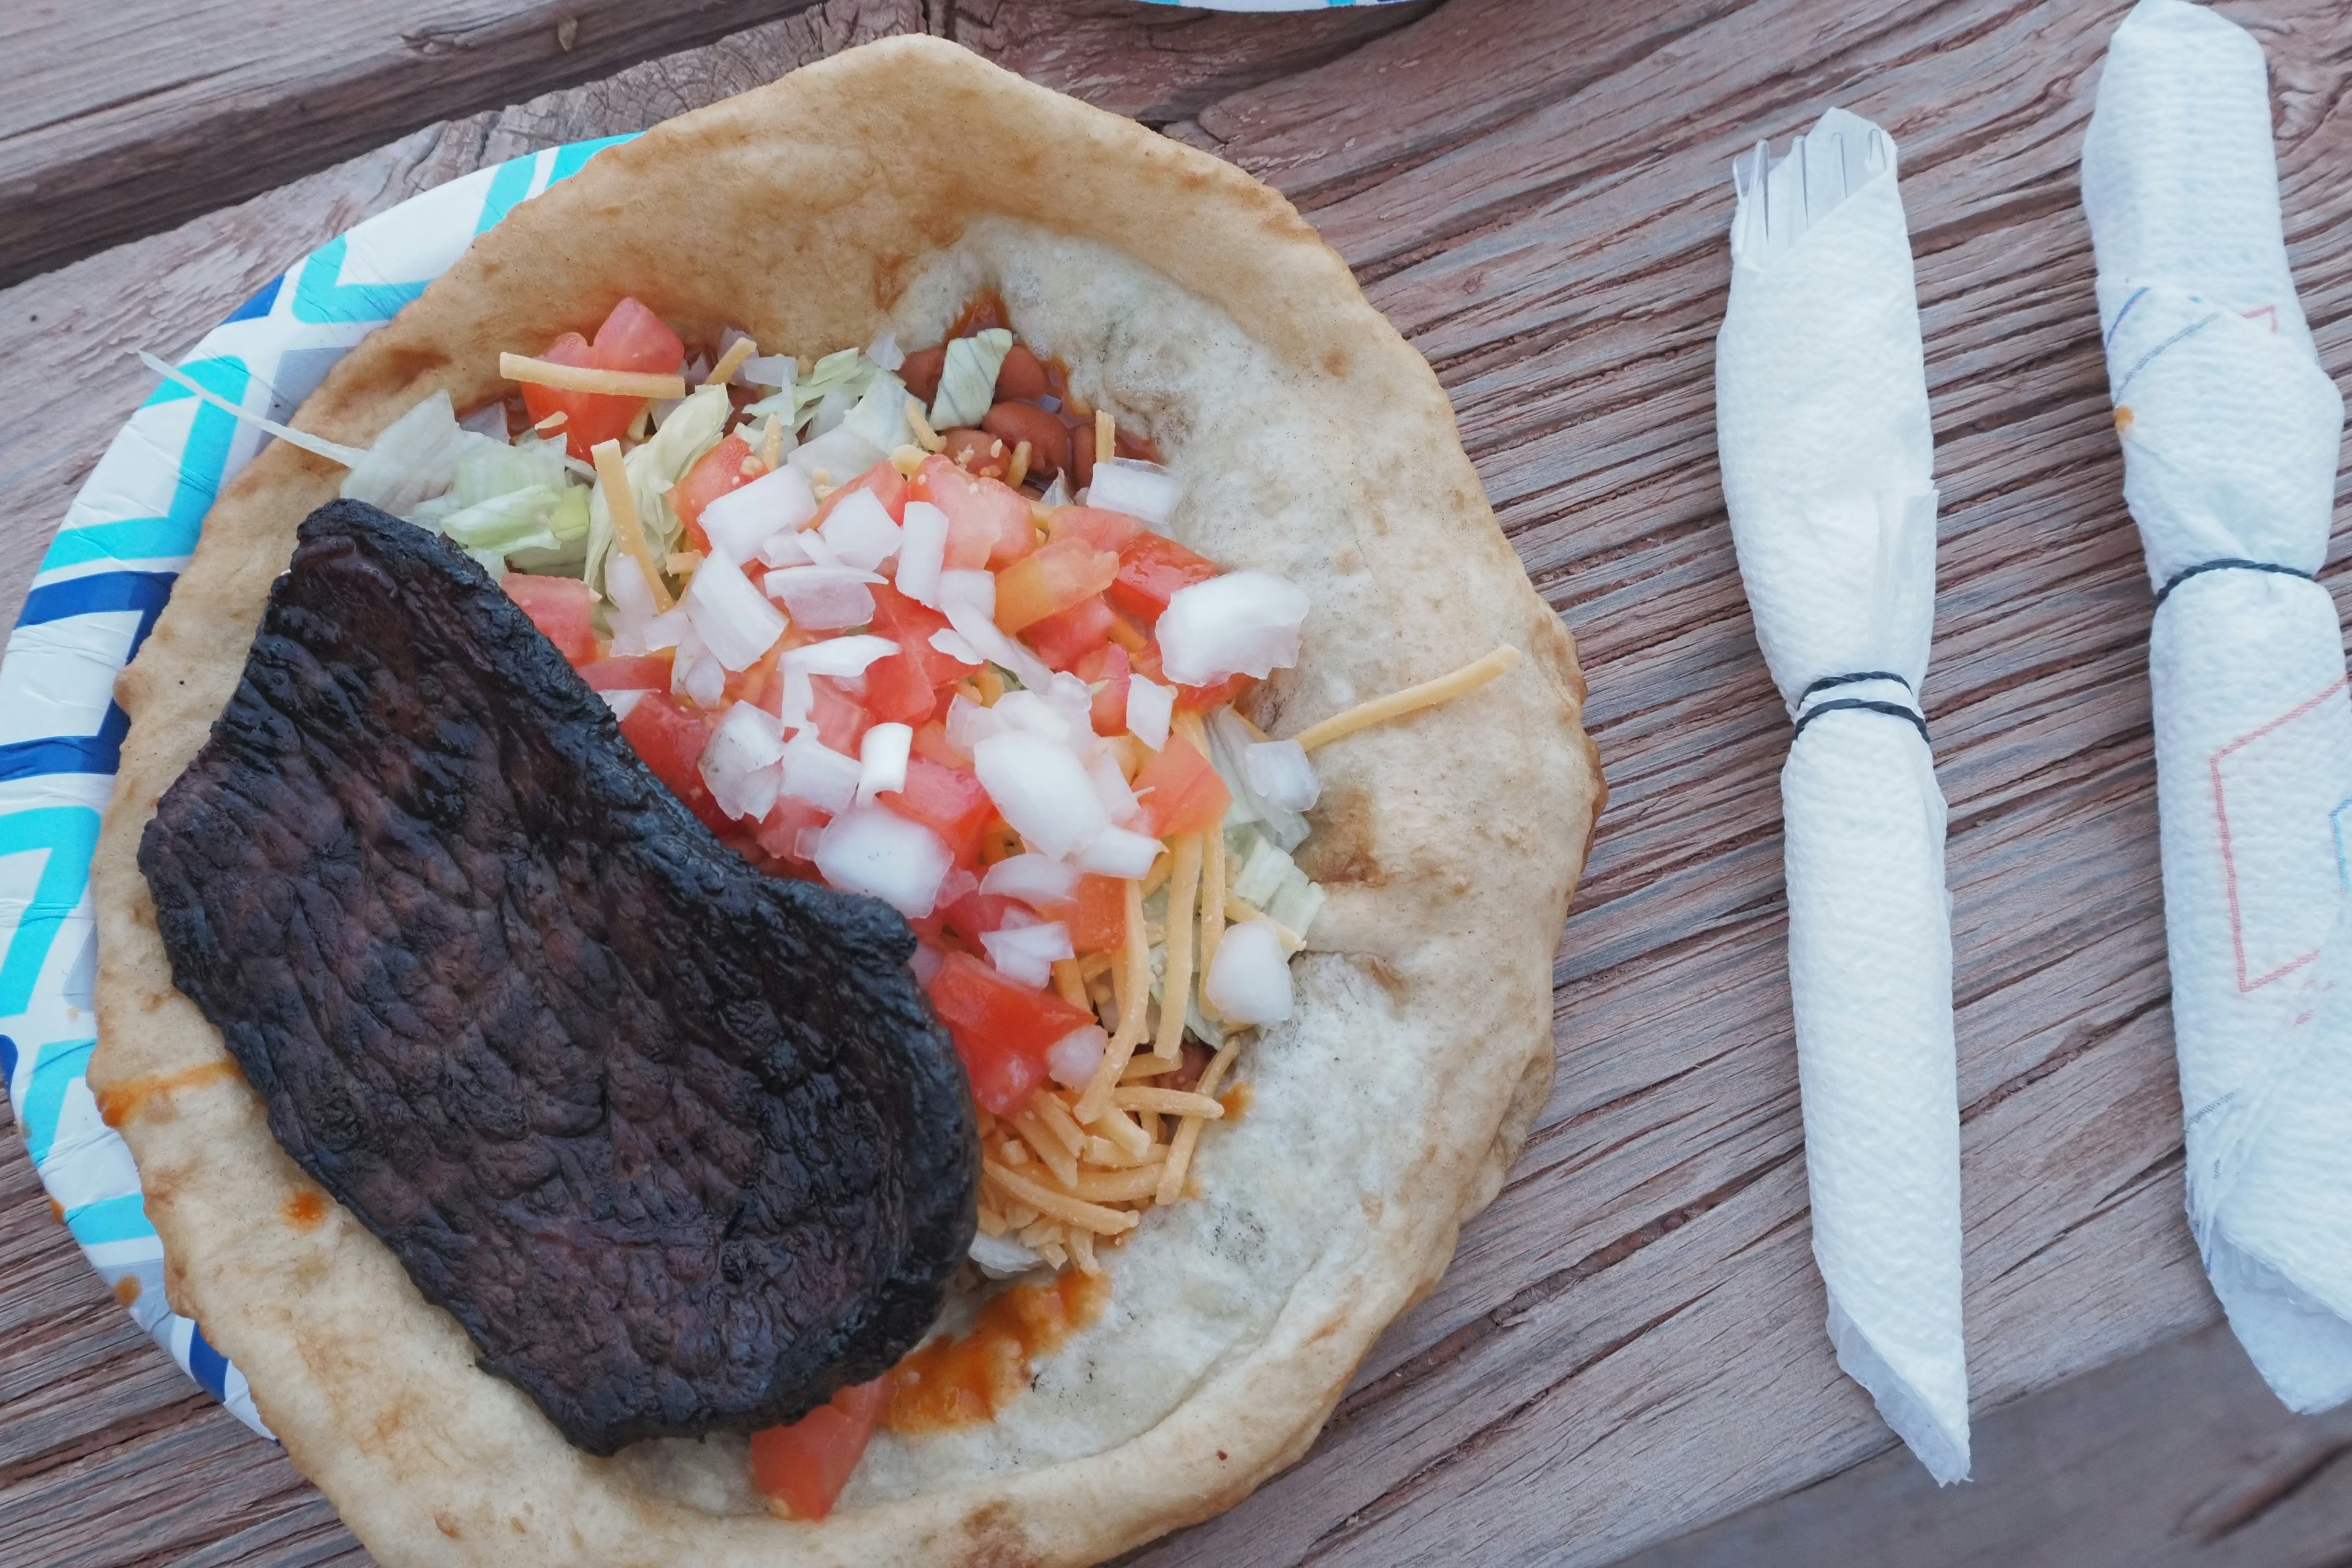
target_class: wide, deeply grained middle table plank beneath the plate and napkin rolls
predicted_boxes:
[0,0,2352,1563]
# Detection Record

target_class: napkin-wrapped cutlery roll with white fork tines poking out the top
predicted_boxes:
[1714,108,1969,1483]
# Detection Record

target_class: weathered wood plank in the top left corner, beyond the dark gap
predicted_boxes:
[0,0,846,284]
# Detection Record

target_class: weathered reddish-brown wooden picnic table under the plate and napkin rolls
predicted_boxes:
[0,0,2352,1568]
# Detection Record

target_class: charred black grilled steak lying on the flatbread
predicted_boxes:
[139,501,978,1453]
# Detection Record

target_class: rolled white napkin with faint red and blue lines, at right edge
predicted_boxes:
[2081,0,2352,1411]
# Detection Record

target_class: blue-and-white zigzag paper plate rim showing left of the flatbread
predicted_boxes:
[0,137,625,1434]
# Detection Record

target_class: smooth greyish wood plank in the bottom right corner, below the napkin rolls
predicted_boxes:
[1623,1324,2352,1568]
